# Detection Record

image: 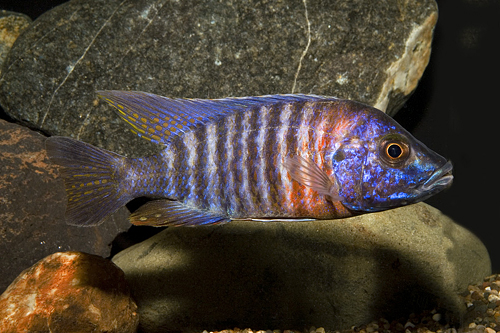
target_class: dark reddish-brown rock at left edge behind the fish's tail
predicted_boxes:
[0,120,130,292]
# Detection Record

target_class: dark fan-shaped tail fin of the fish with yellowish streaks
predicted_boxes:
[46,136,132,226]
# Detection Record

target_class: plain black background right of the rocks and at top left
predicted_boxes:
[0,0,500,273]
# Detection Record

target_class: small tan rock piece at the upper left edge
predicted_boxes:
[0,10,31,75]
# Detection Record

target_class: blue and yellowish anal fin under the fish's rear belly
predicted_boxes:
[130,199,230,227]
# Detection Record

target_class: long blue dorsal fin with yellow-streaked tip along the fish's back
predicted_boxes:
[97,90,335,145]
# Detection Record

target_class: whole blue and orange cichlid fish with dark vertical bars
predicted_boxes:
[46,90,453,226]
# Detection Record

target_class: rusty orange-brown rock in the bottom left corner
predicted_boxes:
[0,252,139,333]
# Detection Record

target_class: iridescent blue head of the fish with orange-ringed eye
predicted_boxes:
[332,111,453,211]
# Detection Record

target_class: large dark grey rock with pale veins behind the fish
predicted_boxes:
[0,0,437,156]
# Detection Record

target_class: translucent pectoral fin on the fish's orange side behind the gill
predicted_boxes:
[284,155,342,201]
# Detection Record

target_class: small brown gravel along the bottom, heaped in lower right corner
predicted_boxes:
[202,274,500,333]
